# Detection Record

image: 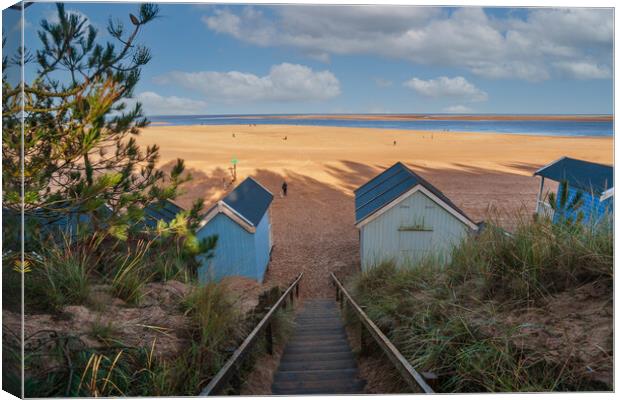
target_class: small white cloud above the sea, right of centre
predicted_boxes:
[404,76,488,101]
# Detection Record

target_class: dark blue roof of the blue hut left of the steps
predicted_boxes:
[200,177,273,233]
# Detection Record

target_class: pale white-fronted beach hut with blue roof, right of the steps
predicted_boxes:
[355,162,478,270]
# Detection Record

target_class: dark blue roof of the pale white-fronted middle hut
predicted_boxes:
[355,162,477,230]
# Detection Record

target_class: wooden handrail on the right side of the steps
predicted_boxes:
[331,272,435,393]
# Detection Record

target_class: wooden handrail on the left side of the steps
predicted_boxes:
[200,272,304,396]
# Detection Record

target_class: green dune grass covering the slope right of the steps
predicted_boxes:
[351,214,613,392]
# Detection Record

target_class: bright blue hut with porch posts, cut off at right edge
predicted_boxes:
[534,157,614,224]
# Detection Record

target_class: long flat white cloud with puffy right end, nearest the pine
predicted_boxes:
[155,62,340,103]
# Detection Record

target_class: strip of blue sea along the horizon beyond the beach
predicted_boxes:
[149,114,614,136]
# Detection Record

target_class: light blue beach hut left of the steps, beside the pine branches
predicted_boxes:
[197,178,273,282]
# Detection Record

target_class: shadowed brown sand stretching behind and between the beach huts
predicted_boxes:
[161,160,539,297]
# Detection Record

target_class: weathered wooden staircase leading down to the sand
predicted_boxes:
[271,300,366,395]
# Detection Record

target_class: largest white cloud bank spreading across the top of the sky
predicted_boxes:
[203,5,613,81]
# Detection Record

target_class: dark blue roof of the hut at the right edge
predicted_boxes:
[534,157,614,194]
